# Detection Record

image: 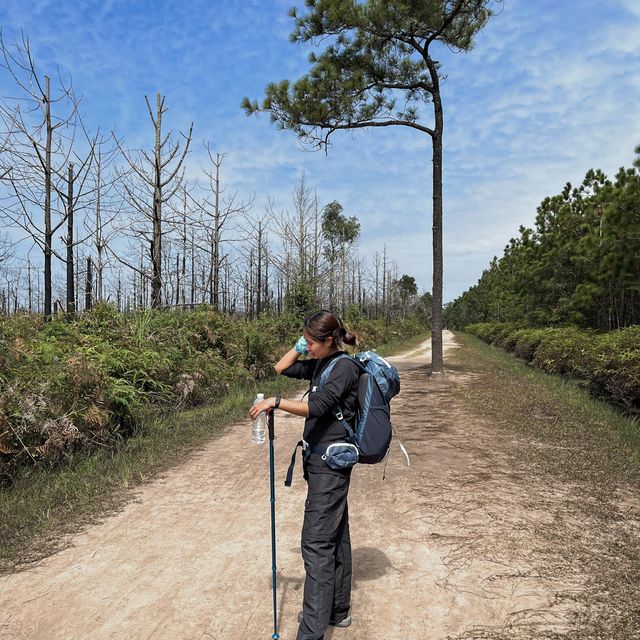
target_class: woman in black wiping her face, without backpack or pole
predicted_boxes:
[250,310,360,640]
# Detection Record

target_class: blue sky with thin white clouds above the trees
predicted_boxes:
[0,0,640,301]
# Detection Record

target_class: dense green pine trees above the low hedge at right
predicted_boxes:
[446,146,640,331]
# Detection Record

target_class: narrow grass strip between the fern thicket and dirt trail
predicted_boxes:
[0,336,425,574]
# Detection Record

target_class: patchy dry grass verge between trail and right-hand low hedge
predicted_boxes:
[451,334,640,640]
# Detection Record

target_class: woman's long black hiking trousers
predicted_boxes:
[297,470,351,640]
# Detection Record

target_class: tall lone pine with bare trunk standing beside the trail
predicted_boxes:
[243,0,499,372]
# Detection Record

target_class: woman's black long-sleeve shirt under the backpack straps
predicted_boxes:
[282,351,360,447]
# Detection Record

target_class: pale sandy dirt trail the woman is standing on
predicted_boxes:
[0,332,579,640]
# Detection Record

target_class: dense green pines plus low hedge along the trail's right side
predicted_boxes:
[445,146,640,415]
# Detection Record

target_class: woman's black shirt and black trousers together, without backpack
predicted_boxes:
[283,351,360,640]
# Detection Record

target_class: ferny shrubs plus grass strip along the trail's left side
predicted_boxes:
[0,305,426,570]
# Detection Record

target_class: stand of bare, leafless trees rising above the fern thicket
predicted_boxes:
[0,34,424,319]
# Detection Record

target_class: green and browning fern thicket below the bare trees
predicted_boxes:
[0,304,421,481]
